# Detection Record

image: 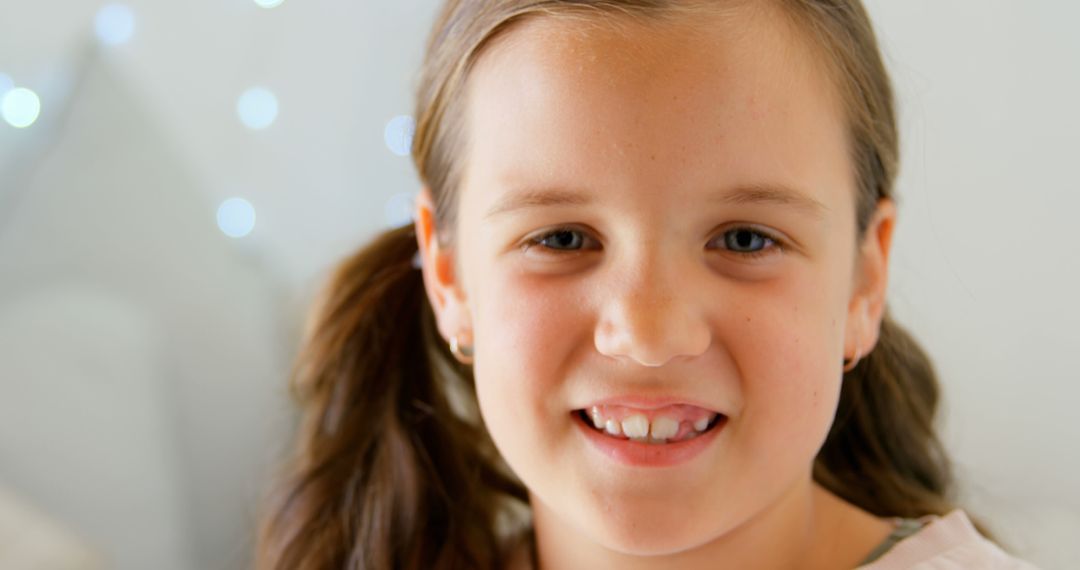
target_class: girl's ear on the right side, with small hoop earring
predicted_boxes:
[843,198,896,357]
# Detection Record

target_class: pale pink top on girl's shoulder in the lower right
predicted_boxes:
[859,508,1038,570]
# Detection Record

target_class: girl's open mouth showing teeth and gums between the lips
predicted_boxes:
[571,405,727,446]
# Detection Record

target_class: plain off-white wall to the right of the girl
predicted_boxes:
[868,0,1080,568]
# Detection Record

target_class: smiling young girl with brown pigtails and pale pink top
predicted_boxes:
[258,0,1029,570]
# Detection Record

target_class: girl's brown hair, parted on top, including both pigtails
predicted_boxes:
[257,0,986,569]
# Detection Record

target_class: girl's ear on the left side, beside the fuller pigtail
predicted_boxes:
[414,187,473,344]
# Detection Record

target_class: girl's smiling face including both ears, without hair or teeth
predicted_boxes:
[418,2,893,554]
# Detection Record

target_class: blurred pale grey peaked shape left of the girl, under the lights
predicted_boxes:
[0,37,296,570]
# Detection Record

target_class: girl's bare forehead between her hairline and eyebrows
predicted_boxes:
[462,4,852,220]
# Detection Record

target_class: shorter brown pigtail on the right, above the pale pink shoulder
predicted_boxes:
[813,310,996,540]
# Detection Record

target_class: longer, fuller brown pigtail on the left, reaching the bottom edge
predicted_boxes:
[257,227,526,570]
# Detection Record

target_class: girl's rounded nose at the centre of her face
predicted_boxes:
[594,253,712,367]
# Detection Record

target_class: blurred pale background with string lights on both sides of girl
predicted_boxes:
[0,0,1080,569]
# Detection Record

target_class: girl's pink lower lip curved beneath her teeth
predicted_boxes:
[570,411,728,467]
